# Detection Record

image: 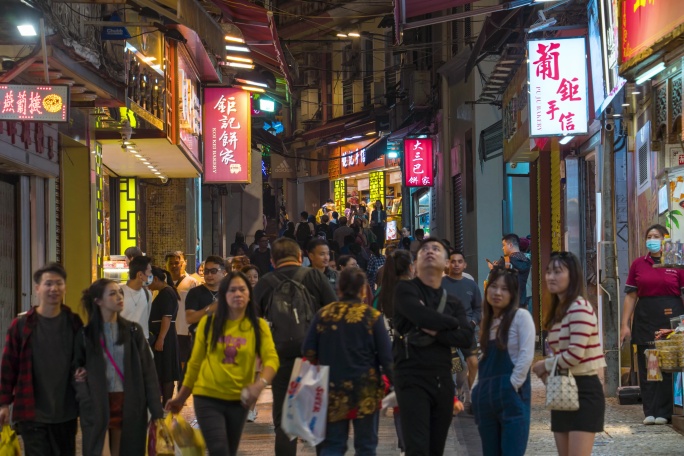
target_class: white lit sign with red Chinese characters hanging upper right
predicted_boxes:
[527,37,589,137]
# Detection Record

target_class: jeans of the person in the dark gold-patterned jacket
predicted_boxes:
[318,412,380,456]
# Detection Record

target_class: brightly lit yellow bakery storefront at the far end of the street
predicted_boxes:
[328,140,402,242]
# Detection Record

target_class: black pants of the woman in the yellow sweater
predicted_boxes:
[194,396,247,456]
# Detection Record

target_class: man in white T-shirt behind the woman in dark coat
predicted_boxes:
[121,256,153,339]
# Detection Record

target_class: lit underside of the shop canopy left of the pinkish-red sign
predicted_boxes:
[100,138,200,178]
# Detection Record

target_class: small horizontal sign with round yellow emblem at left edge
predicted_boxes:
[0,84,69,122]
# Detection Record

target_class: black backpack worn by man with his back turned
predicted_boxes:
[263,267,316,358]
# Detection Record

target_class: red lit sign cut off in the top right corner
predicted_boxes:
[620,0,684,67]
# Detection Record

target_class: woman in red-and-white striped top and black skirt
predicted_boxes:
[532,252,606,455]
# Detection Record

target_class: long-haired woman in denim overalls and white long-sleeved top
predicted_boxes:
[472,267,534,456]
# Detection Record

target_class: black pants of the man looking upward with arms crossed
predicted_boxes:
[394,371,454,456]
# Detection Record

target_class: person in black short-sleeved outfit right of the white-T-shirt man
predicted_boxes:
[149,266,181,403]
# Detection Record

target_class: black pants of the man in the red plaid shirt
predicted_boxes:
[17,419,78,456]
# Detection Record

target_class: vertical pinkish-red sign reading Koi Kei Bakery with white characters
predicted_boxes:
[203,87,252,184]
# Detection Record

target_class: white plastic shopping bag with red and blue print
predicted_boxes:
[280,358,330,446]
